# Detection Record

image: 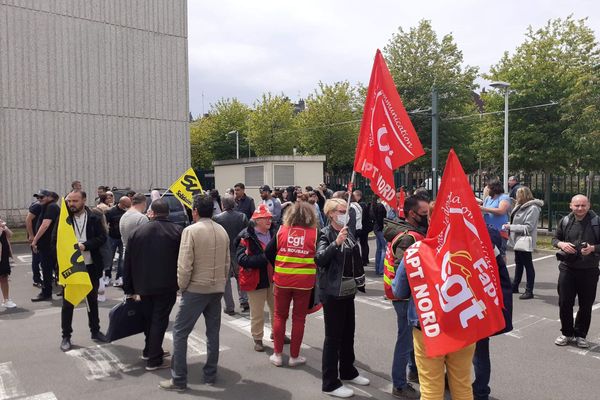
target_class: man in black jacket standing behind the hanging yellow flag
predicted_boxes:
[60,190,106,351]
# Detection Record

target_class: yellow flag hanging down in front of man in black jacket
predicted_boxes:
[56,198,92,306]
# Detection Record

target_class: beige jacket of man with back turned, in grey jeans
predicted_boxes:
[177,218,230,293]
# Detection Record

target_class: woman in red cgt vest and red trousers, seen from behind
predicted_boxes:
[266,201,317,367]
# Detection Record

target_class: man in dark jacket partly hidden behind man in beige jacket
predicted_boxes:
[213,195,250,315]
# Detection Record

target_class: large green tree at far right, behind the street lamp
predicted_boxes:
[474,17,599,175]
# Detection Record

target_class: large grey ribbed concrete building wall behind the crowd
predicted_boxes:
[0,0,190,225]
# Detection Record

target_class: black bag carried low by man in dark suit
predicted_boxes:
[106,298,144,342]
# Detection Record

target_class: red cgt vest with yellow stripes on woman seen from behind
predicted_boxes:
[273,225,317,289]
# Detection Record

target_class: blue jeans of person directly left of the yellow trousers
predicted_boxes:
[392,301,417,389]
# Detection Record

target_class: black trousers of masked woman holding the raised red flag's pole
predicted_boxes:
[322,298,358,392]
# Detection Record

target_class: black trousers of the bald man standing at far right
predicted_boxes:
[558,268,600,338]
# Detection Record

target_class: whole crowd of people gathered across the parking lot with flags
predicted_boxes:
[0,177,600,400]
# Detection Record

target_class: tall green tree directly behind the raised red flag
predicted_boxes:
[383,20,477,170]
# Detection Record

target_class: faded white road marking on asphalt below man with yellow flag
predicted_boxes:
[66,345,141,380]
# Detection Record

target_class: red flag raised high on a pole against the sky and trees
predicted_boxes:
[354,50,425,209]
